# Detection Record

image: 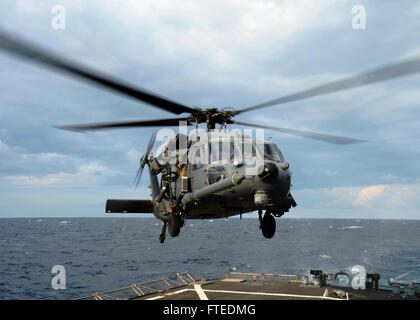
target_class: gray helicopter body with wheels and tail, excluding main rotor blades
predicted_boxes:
[106,130,296,242]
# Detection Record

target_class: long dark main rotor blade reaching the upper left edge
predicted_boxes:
[0,30,195,114]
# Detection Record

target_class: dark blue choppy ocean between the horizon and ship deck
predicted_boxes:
[0,218,420,299]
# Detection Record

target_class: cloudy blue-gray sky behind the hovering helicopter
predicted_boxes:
[0,0,420,219]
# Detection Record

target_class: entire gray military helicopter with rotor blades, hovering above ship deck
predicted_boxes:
[0,31,420,243]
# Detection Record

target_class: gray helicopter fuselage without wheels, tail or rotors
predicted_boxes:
[150,134,296,221]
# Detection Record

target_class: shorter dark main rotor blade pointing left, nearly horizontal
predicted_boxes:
[55,118,190,131]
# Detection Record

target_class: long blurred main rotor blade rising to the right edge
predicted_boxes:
[236,56,420,114]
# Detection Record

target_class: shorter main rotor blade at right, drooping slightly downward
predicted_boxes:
[231,121,366,144]
